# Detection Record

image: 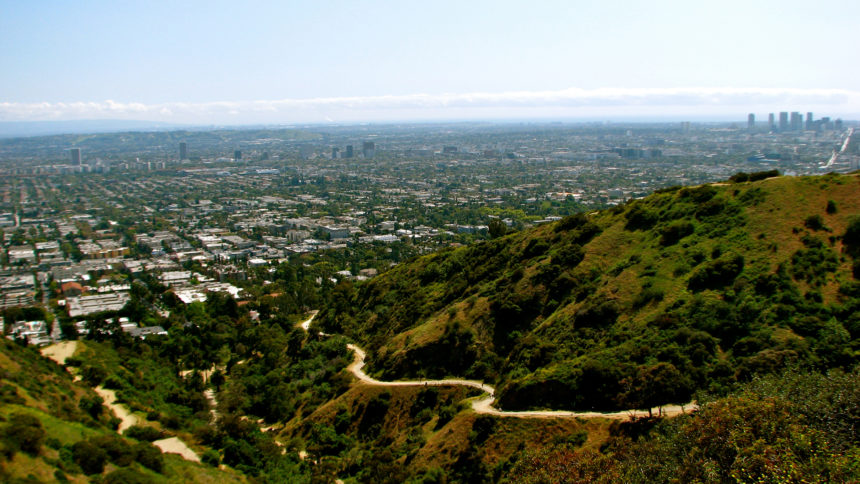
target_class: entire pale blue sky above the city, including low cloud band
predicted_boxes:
[0,0,860,125]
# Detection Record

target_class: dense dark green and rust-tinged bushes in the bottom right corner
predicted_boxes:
[507,369,860,484]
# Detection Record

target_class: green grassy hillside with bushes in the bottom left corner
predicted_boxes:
[0,338,245,483]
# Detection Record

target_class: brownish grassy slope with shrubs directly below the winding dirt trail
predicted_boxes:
[288,383,596,482]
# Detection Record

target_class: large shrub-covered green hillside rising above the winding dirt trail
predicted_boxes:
[315,175,860,410]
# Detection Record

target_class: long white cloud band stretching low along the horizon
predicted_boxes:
[0,88,860,124]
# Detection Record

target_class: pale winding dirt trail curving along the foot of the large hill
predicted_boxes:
[301,311,698,420]
